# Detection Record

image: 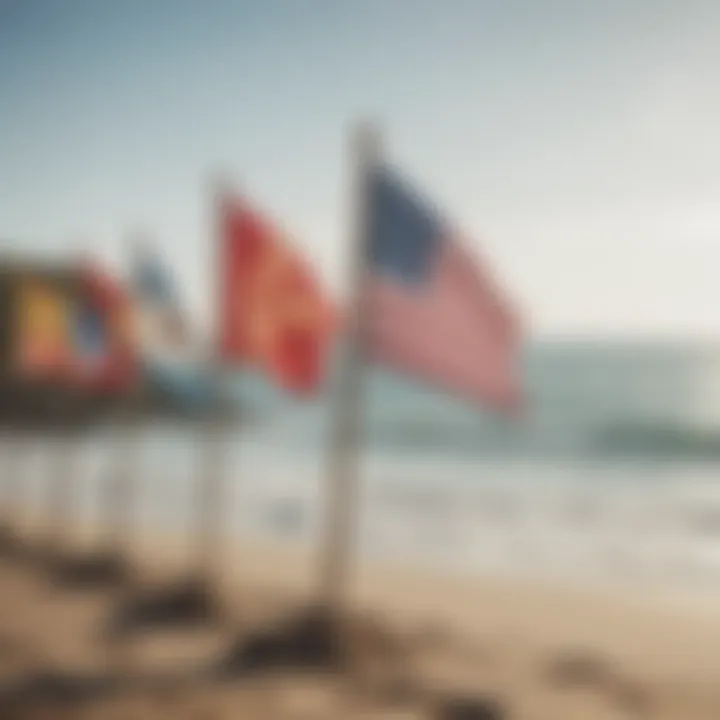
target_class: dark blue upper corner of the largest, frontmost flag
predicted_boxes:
[368,169,443,283]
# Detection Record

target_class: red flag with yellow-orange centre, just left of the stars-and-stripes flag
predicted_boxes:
[219,198,334,392]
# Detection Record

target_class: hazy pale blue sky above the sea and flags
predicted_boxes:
[0,0,720,339]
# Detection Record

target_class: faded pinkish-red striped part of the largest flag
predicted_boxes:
[367,238,519,406]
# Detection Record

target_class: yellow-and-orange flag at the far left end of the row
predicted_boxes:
[15,280,71,379]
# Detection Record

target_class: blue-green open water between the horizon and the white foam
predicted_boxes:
[232,343,720,463]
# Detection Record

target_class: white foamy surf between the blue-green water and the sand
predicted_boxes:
[35,430,720,612]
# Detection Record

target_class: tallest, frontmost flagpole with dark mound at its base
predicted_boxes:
[221,124,380,675]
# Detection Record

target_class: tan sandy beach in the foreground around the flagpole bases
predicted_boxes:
[0,524,720,720]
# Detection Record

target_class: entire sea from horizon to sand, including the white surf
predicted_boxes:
[12,341,720,598]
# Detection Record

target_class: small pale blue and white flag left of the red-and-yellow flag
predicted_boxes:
[132,246,190,357]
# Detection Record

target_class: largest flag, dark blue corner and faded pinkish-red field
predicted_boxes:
[363,166,519,409]
